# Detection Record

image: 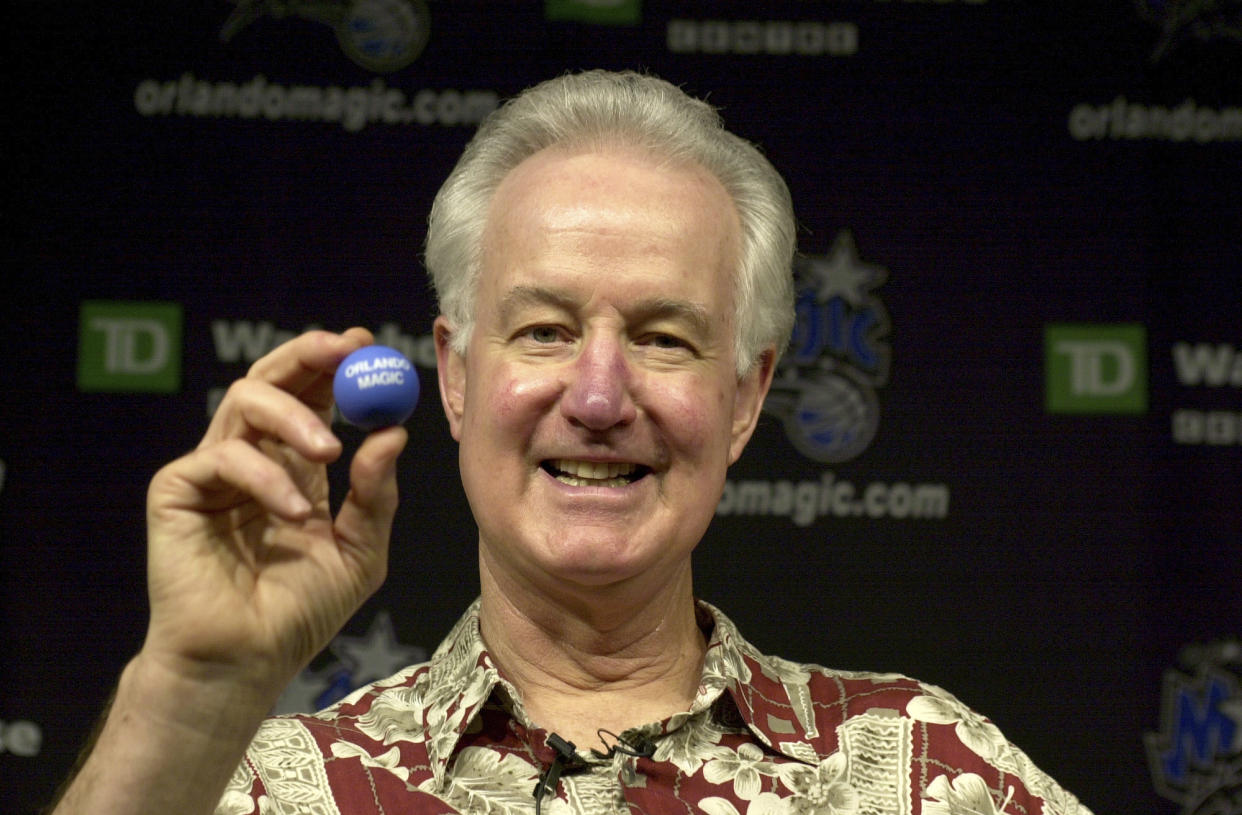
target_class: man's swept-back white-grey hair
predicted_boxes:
[426,71,795,376]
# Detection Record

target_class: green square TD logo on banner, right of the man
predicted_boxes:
[1043,323,1148,414]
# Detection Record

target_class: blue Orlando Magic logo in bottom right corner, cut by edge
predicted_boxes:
[1146,640,1242,815]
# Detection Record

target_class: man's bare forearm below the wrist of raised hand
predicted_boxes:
[52,655,271,815]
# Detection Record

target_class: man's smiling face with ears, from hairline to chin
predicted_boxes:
[436,150,771,591]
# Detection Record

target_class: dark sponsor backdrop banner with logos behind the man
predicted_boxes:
[0,0,1242,815]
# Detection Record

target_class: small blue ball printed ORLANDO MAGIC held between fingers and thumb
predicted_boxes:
[332,345,419,431]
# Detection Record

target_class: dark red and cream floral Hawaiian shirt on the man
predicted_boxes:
[216,601,1090,815]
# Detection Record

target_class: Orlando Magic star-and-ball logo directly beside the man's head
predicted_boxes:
[764,231,889,463]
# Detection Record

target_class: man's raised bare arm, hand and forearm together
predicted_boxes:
[55,328,406,815]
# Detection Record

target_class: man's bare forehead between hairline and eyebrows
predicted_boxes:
[483,148,740,301]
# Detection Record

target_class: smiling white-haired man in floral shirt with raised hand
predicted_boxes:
[58,72,1087,815]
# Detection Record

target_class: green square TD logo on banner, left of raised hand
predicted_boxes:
[77,301,181,393]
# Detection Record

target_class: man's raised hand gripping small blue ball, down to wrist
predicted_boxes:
[143,329,406,699]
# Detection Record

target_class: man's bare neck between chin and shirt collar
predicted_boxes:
[479,562,705,747]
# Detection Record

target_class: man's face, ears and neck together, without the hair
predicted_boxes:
[436,140,775,744]
